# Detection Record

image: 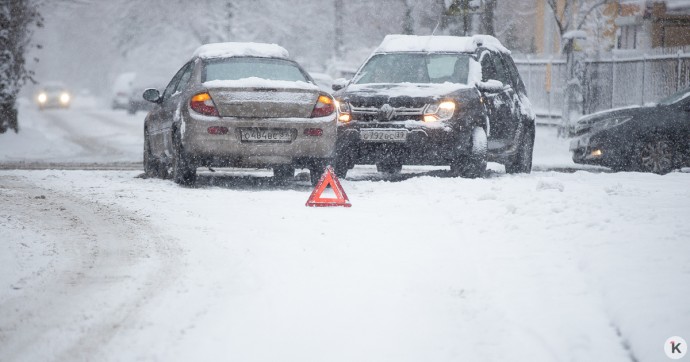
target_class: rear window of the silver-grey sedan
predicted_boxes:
[202,57,308,82]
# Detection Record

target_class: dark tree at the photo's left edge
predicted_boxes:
[0,0,43,133]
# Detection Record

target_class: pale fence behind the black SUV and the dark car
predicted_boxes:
[515,49,690,119]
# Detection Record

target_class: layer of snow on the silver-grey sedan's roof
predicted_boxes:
[192,42,290,59]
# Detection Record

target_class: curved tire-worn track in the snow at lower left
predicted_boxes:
[0,177,181,361]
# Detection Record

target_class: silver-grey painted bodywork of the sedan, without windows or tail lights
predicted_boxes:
[144,56,336,171]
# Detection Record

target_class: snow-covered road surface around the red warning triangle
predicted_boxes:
[0,100,690,361]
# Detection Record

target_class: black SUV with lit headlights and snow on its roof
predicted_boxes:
[333,35,535,177]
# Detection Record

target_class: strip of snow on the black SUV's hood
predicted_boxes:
[347,82,473,98]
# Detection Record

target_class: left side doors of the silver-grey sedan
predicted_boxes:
[149,62,191,157]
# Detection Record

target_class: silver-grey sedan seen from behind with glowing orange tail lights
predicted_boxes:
[143,43,336,185]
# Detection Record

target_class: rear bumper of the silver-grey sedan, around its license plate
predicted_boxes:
[182,115,336,167]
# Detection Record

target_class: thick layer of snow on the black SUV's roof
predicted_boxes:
[375,34,510,54]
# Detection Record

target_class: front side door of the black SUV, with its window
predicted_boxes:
[479,50,516,149]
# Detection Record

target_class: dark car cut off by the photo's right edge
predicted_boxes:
[570,88,690,174]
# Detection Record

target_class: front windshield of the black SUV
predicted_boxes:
[354,53,470,84]
